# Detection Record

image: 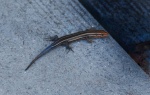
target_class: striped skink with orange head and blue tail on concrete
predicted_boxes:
[25,29,108,71]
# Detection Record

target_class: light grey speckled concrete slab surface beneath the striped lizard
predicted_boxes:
[0,0,150,95]
